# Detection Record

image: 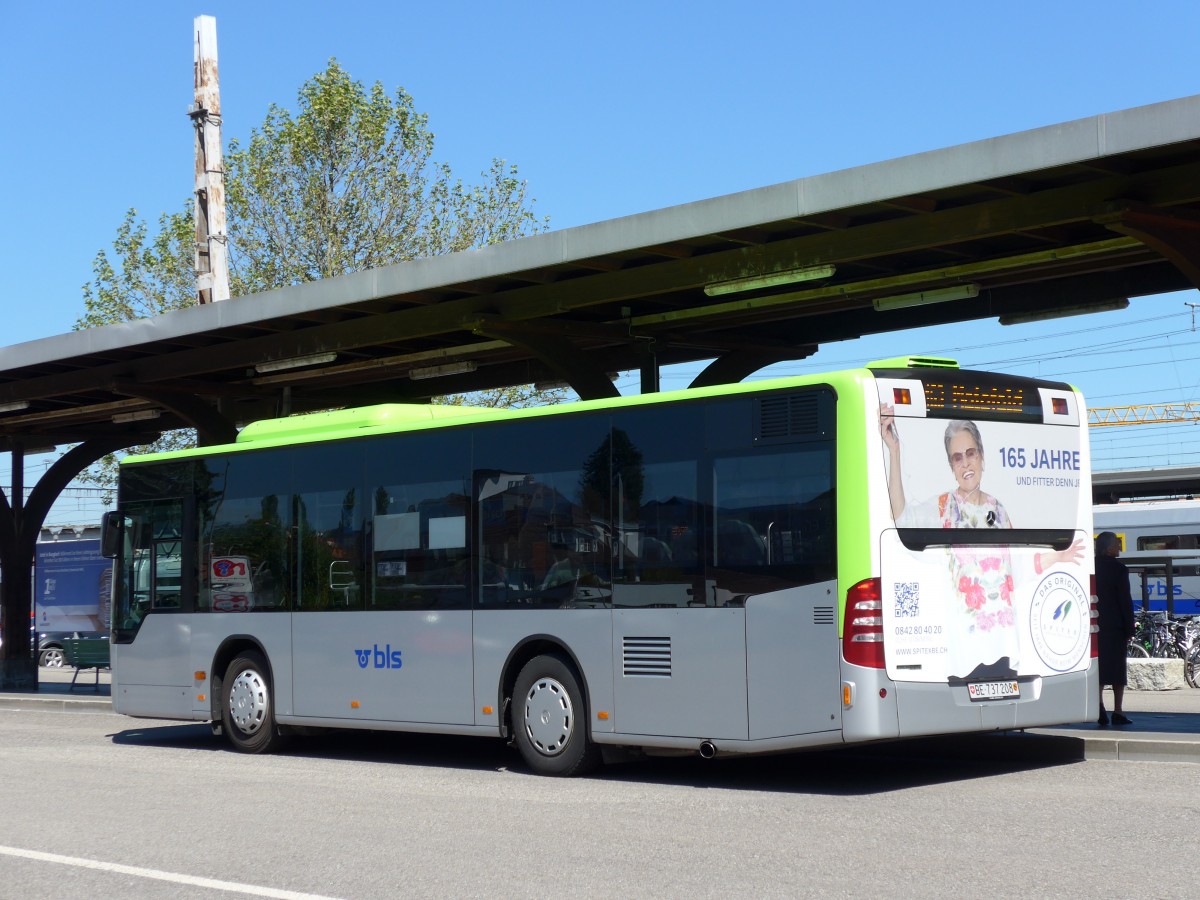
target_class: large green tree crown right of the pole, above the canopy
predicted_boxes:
[226,60,545,294]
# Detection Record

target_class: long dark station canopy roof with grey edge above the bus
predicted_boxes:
[7,96,1200,450]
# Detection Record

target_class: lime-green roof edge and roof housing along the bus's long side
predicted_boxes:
[120,368,869,466]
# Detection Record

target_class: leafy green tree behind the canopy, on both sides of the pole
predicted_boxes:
[76,59,564,501]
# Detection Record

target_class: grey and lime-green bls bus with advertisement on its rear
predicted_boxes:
[104,358,1099,775]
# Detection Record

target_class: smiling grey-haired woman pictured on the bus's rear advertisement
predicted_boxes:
[880,404,1084,679]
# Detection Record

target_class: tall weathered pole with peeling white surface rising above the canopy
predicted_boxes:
[187,16,229,304]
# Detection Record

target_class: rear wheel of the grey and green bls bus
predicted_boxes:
[512,655,600,778]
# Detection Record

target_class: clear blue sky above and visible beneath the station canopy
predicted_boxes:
[0,0,1200,523]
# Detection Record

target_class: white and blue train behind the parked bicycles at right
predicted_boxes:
[1092,499,1200,616]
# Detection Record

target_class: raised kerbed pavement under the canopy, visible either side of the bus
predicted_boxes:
[0,668,1200,764]
